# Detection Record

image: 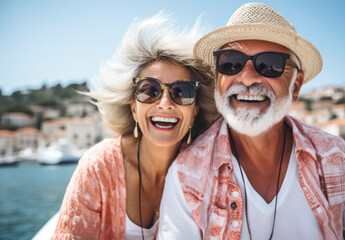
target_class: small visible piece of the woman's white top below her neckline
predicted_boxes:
[125,214,158,240]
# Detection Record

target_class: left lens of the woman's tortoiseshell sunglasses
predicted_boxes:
[136,79,161,103]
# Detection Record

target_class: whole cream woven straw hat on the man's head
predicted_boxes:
[194,3,322,83]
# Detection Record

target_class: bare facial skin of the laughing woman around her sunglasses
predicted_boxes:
[131,62,198,146]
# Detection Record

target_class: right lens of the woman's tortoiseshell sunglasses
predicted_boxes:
[170,81,196,105]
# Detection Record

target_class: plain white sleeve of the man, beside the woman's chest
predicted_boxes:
[157,162,202,240]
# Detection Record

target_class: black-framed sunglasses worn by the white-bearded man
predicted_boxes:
[213,49,296,78]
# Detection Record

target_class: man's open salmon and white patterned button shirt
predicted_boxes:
[176,116,345,240]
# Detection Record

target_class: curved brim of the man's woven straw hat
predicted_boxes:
[193,23,322,83]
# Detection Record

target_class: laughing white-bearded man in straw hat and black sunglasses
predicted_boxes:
[158,3,345,240]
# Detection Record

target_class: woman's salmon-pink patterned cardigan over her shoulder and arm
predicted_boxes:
[52,136,126,240]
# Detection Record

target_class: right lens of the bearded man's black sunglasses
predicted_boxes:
[256,53,285,78]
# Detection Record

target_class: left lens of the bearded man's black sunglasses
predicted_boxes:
[217,51,247,75]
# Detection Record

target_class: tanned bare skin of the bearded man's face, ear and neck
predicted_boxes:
[216,40,303,203]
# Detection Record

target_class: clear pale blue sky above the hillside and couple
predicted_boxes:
[0,0,345,94]
